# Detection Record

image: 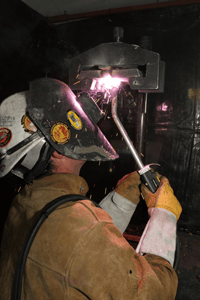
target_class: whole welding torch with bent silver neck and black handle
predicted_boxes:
[111,95,160,193]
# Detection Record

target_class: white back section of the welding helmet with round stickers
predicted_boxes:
[0,91,45,178]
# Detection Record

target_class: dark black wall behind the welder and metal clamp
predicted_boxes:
[0,0,200,238]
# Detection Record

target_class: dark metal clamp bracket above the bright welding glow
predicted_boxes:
[69,42,165,93]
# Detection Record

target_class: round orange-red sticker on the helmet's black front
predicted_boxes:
[51,122,71,145]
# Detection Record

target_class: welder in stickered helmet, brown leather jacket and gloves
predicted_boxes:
[0,78,182,300]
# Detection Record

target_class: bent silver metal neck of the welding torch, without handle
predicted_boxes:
[111,95,144,170]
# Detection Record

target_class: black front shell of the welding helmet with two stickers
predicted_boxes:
[27,78,119,161]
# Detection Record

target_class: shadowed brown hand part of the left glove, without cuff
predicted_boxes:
[115,172,141,205]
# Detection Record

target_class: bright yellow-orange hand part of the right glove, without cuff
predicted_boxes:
[141,175,182,221]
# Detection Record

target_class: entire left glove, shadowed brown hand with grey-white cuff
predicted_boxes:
[99,172,141,233]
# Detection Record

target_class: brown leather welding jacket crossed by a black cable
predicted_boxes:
[0,174,178,300]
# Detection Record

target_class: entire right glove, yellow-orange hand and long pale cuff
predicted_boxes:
[136,177,182,266]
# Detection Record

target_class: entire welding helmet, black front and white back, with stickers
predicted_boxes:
[0,78,118,182]
